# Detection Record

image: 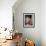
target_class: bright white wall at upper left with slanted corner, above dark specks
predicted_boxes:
[0,0,16,29]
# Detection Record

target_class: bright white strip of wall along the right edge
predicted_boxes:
[40,0,46,46]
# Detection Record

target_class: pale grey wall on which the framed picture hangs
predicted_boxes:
[13,0,41,46]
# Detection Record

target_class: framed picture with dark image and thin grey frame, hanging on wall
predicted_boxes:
[23,13,35,28]
